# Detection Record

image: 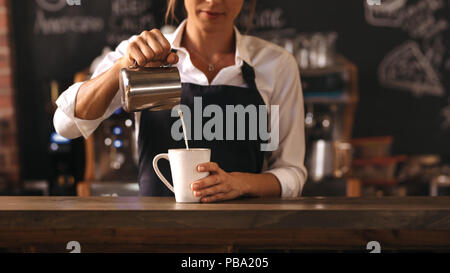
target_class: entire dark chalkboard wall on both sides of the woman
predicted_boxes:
[11,0,450,179]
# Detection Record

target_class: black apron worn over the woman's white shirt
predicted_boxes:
[138,62,267,196]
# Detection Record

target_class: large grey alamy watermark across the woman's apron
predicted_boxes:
[171,97,280,152]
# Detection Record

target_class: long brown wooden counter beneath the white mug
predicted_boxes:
[0,197,450,252]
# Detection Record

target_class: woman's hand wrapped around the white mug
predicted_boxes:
[191,162,246,203]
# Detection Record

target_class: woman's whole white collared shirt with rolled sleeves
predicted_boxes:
[54,21,307,197]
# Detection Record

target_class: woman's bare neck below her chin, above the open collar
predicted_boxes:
[182,20,235,60]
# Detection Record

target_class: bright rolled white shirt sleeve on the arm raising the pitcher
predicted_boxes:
[53,37,134,139]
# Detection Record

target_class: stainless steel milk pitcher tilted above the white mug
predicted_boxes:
[119,63,181,112]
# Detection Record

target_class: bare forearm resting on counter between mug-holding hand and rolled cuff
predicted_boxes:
[239,173,281,197]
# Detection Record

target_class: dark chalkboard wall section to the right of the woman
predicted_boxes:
[243,0,450,159]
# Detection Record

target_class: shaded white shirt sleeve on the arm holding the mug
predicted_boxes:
[264,54,307,197]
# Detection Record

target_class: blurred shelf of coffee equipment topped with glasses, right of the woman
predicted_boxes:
[294,32,358,184]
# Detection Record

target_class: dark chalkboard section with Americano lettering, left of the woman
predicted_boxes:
[11,0,166,179]
